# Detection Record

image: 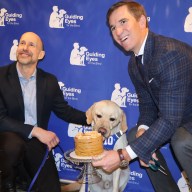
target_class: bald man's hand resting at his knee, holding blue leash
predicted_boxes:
[31,127,59,151]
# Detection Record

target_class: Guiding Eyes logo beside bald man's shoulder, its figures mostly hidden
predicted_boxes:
[58,81,81,100]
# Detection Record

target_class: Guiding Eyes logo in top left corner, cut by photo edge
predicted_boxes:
[0,8,23,27]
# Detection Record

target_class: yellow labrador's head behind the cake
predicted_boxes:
[86,100,128,138]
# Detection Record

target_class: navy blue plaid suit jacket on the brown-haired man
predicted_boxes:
[129,31,192,162]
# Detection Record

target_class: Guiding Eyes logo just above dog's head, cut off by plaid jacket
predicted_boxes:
[111,83,139,107]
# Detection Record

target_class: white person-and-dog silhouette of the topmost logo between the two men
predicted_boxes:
[49,6,67,28]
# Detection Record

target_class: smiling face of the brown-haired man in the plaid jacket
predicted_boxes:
[109,5,146,53]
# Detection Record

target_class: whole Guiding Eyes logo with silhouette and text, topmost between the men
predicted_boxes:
[49,5,83,28]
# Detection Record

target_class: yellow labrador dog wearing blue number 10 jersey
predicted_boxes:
[63,100,130,192]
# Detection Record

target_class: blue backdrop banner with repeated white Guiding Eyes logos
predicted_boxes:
[0,0,192,192]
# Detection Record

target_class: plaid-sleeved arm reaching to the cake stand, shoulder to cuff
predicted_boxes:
[130,51,191,163]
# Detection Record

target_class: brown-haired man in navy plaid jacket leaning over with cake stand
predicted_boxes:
[93,1,192,192]
